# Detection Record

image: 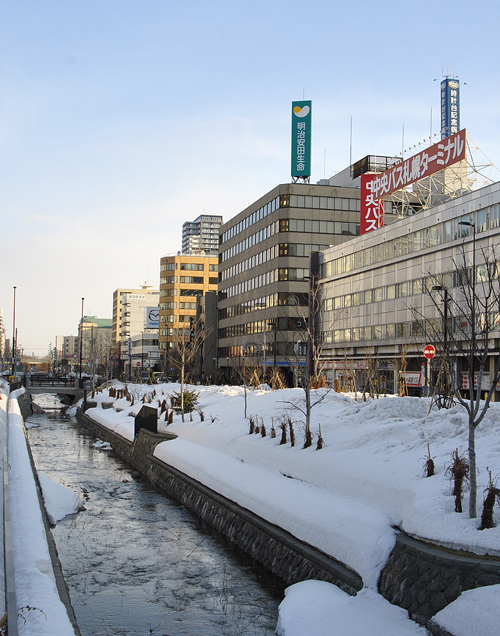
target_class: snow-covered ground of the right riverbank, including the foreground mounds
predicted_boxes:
[69,384,500,636]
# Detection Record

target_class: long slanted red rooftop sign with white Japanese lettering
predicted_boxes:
[372,128,466,199]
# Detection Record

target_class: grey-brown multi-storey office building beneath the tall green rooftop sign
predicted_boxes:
[218,173,395,381]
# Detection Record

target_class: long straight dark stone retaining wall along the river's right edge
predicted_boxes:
[77,411,363,595]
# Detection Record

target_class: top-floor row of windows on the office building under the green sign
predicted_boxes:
[221,194,360,244]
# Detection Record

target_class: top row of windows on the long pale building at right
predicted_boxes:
[321,204,500,278]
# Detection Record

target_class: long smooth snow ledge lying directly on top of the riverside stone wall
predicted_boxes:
[154,439,395,586]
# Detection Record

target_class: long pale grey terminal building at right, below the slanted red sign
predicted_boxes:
[317,183,500,393]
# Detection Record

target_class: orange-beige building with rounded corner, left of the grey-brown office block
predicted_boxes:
[159,253,218,356]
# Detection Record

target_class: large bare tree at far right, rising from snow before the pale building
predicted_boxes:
[429,249,500,518]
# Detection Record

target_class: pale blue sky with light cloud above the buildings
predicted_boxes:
[0,0,500,355]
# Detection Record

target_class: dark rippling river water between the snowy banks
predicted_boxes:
[27,396,283,636]
